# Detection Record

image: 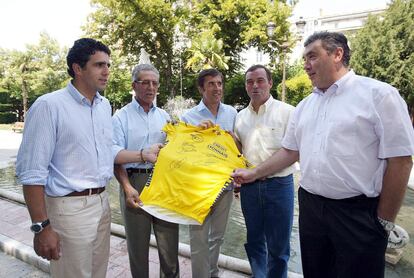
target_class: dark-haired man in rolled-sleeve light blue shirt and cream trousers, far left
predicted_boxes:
[16,38,113,277]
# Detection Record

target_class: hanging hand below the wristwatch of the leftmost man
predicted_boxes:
[33,225,61,261]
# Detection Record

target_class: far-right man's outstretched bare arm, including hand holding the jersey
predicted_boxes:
[232,148,299,183]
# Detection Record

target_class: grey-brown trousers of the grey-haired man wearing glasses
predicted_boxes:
[119,173,180,278]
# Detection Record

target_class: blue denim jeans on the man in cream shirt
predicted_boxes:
[240,175,294,278]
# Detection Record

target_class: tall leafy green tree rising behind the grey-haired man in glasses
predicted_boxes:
[85,0,181,100]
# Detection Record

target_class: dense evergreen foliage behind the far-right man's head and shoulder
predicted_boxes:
[351,0,414,120]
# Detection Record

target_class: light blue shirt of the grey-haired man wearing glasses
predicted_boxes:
[112,98,170,168]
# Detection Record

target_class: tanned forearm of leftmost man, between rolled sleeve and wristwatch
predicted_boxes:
[23,185,48,222]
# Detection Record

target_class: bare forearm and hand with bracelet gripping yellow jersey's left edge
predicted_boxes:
[115,143,163,164]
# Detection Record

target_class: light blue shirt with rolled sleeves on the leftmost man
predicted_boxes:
[16,83,113,196]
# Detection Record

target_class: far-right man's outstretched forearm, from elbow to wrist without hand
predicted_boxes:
[255,148,299,179]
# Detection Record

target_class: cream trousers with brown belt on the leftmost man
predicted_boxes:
[45,191,111,278]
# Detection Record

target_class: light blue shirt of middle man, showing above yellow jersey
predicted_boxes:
[181,100,237,131]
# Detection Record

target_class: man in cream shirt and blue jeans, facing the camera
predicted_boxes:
[234,65,295,278]
